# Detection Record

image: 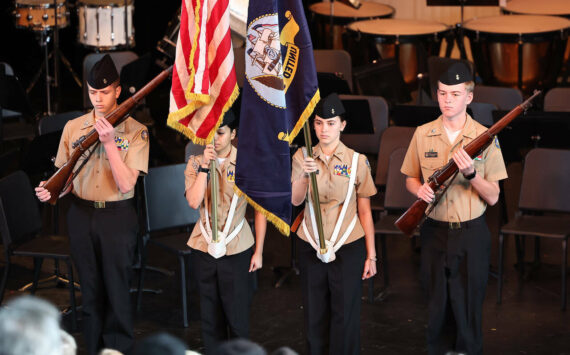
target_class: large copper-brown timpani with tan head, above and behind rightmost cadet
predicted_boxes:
[463,15,570,93]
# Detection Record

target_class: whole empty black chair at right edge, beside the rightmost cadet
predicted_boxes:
[497,148,570,310]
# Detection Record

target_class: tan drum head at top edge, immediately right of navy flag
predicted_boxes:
[309,1,394,19]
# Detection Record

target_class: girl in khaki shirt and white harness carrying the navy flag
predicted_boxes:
[291,94,376,354]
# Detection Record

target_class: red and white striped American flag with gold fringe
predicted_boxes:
[167,0,239,144]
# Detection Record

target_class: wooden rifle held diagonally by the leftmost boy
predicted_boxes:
[42,67,172,205]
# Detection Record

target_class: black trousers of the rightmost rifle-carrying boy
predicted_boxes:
[420,215,491,355]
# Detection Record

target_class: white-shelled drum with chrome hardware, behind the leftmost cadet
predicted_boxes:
[77,0,135,50]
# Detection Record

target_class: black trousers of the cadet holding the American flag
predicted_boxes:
[194,248,253,353]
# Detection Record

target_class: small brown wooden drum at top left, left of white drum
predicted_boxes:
[14,0,69,31]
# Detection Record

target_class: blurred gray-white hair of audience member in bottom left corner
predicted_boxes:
[0,296,63,355]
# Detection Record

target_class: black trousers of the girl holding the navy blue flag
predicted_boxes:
[297,238,366,355]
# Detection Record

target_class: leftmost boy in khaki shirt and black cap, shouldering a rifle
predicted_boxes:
[36,55,149,355]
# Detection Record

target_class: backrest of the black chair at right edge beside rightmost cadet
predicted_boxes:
[519,148,570,213]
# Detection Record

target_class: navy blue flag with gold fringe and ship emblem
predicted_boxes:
[235,0,320,235]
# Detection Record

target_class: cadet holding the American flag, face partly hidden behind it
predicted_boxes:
[184,110,267,353]
